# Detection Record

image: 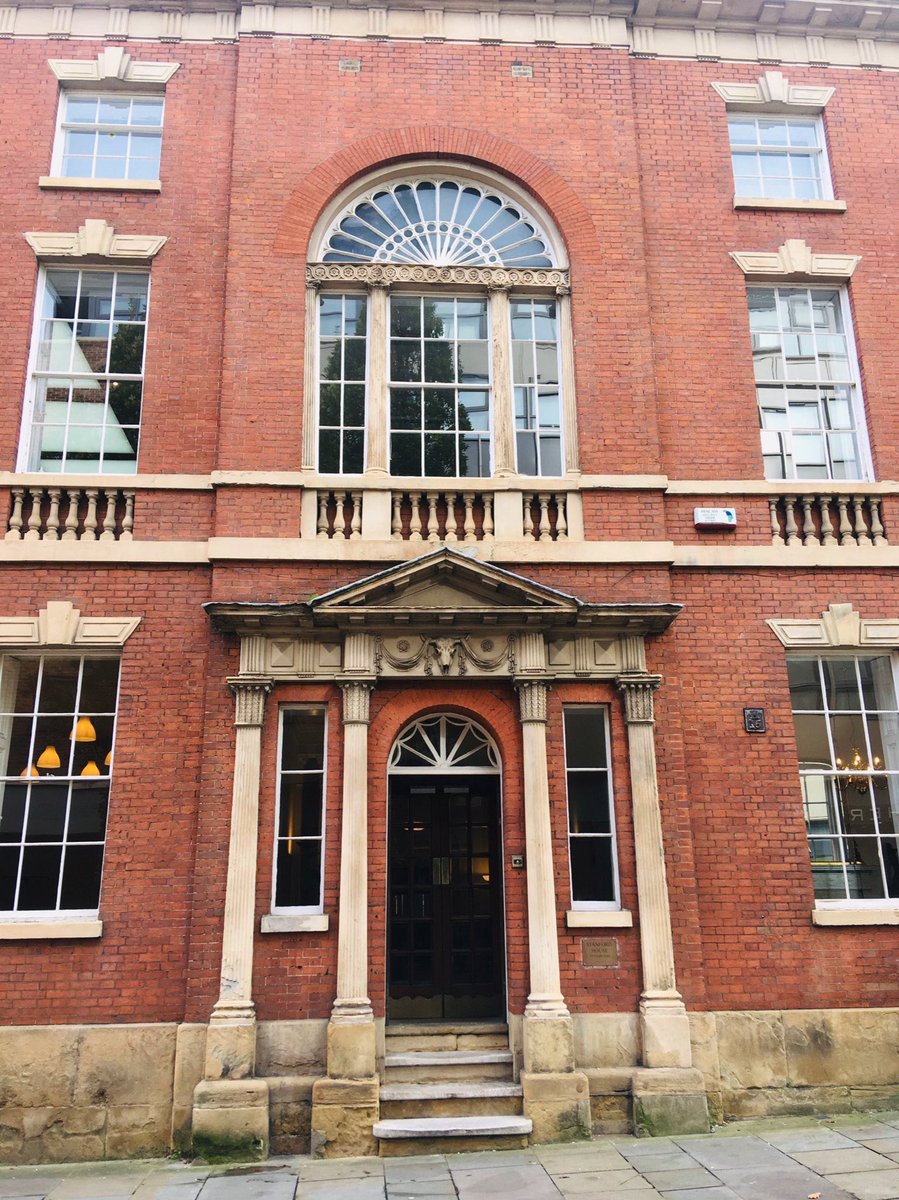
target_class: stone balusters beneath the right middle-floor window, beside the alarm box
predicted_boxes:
[768,492,889,550]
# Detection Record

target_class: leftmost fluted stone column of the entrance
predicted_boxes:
[205,676,271,1079]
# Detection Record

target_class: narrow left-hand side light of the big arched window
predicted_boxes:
[318,293,367,475]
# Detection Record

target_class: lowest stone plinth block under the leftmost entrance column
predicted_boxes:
[191,1079,269,1162]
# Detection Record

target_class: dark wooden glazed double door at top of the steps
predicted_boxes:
[388,773,505,1021]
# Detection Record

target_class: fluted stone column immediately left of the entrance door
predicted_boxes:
[328,681,374,1079]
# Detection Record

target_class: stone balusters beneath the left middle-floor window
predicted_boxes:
[5,485,134,541]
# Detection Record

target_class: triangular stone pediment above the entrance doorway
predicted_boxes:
[310,548,580,624]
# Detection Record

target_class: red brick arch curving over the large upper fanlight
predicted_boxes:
[275,126,598,259]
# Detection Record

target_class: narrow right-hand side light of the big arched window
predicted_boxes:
[510,299,562,475]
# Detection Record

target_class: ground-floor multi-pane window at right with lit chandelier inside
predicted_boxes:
[787,655,899,901]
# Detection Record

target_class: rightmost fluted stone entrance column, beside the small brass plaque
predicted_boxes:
[616,671,691,1067]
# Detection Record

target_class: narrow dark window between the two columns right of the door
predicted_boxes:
[564,706,618,908]
